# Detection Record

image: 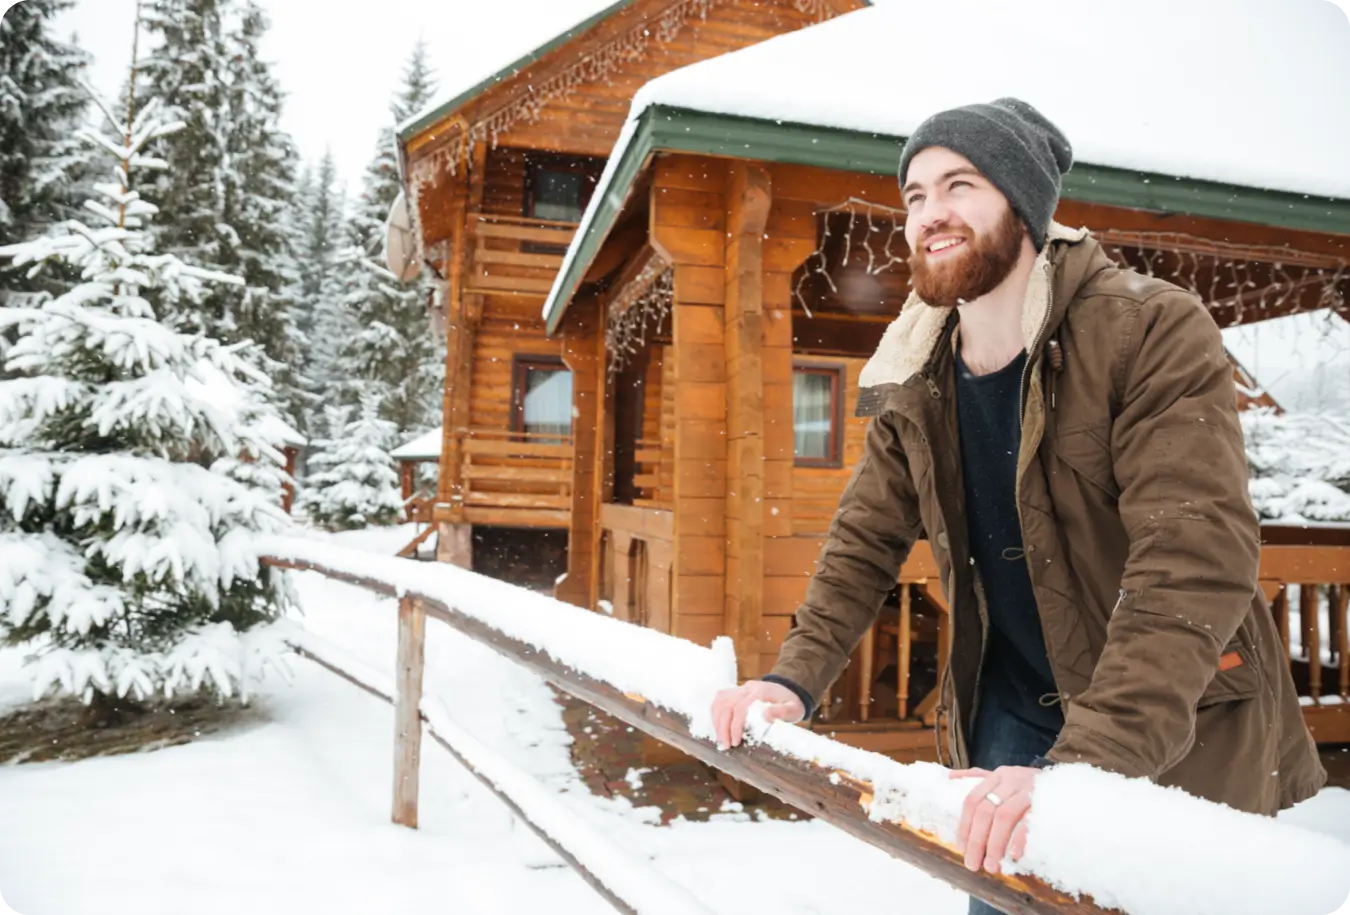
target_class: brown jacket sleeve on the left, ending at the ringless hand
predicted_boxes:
[770,414,922,707]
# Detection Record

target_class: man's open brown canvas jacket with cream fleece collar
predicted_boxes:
[772,225,1326,814]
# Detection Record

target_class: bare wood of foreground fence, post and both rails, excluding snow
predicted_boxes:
[263,557,1104,915]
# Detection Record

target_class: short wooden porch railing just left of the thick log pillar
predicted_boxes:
[599,505,675,633]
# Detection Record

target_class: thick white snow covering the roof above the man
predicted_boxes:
[629,0,1350,198]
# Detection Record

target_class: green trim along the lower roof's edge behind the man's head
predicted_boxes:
[544,105,1350,333]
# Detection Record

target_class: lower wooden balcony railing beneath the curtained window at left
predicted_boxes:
[459,429,572,528]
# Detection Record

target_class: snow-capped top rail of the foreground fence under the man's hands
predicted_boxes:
[261,538,1350,915]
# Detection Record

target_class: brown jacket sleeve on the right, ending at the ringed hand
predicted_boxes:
[1046,292,1261,779]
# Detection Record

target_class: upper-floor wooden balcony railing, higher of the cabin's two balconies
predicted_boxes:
[464,213,576,298]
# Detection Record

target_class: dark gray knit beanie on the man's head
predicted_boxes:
[900,99,1073,251]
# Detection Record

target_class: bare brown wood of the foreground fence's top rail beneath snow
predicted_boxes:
[263,556,1104,915]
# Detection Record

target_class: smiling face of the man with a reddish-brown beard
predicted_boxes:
[900,147,1034,308]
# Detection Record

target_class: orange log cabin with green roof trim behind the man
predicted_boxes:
[402,0,1350,760]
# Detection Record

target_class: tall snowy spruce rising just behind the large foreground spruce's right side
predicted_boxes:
[142,0,305,421]
